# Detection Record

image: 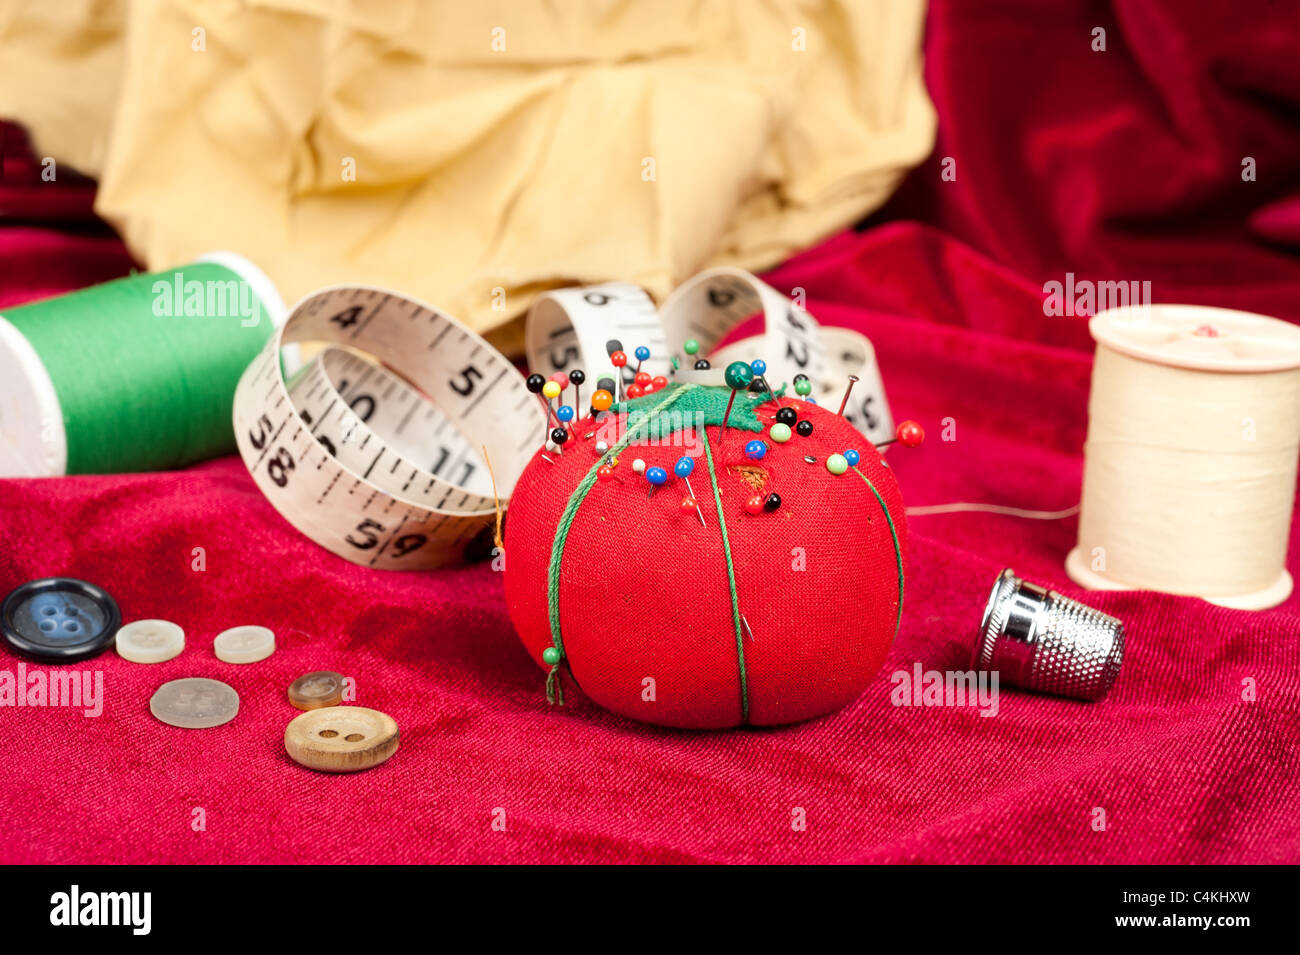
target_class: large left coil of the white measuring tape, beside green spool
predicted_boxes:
[234,286,543,570]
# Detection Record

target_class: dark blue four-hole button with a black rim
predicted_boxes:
[0,577,122,663]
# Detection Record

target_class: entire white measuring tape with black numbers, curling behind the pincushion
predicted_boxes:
[234,269,893,570]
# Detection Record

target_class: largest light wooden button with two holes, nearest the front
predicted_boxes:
[285,707,398,773]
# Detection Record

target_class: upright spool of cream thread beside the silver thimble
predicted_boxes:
[1066,305,1300,609]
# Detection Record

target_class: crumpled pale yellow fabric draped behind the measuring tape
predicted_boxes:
[0,0,935,330]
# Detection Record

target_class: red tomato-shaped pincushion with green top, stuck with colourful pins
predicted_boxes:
[506,385,906,729]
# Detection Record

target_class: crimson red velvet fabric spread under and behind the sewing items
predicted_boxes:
[0,0,1300,863]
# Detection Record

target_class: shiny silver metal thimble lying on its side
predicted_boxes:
[972,568,1125,702]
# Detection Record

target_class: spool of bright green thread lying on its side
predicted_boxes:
[0,252,285,477]
